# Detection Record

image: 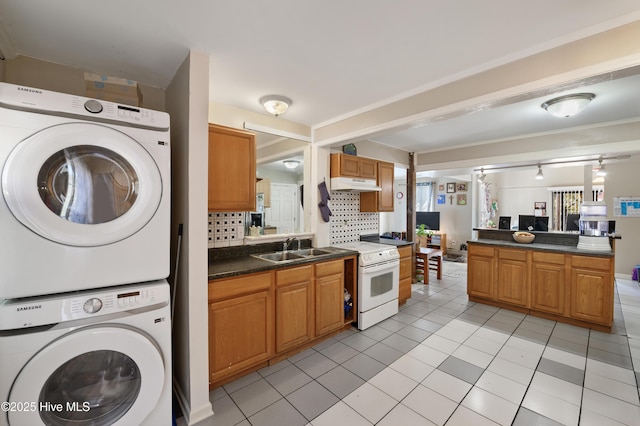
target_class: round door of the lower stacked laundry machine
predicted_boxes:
[9,326,165,426]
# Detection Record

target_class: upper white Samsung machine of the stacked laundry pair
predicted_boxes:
[0,83,171,299]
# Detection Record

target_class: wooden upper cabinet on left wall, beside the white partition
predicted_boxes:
[209,124,256,211]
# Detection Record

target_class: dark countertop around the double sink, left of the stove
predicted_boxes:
[208,247,358,280]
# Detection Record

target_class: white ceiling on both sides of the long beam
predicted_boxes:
[0,0,640,173]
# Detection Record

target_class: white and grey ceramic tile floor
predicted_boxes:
[189,262,640,426]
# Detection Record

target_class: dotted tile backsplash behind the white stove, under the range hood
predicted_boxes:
[329,191,380,244]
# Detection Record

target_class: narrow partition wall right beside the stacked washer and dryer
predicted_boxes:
[166,51,213,425]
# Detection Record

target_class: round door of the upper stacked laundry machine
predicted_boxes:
[2,123,162,247]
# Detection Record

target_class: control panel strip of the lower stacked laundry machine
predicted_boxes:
[0,280,170,331]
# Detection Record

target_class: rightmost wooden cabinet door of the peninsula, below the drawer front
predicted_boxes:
[571,267,613,325]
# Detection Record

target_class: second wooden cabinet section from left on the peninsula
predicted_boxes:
[496,248,529,307]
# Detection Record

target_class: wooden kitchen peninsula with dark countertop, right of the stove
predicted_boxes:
[467,229,615,332]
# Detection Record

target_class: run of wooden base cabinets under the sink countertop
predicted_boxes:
[209,256,357,389]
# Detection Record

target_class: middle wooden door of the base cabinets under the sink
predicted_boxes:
[276,265,314,353]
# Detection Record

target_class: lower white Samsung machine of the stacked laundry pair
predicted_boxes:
[0,280,172,426]
